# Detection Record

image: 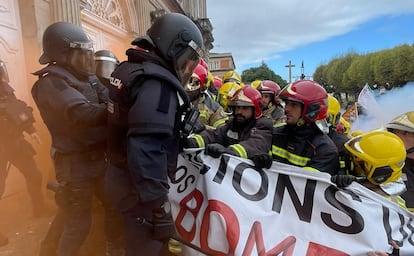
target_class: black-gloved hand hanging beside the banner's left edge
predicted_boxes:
[152,202,176,243]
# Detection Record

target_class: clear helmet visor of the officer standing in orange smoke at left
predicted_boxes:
[68,41,96,75]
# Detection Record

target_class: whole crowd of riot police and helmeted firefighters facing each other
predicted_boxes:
[0,11,414,256]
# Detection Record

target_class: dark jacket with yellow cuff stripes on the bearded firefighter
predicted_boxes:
[193,116,272,158]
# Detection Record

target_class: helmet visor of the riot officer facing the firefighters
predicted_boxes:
[174,41,202,86]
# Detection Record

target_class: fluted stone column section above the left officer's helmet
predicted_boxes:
[50,0,81,26]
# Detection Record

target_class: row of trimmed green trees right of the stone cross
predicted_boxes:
[313,44,414,93]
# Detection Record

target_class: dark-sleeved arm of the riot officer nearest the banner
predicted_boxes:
[127,80,179,202]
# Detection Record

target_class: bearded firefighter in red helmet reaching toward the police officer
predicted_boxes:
[184,86,272,158]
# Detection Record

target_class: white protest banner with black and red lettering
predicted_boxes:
[170,149,414,256]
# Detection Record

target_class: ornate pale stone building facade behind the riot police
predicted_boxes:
[0,0,214,176]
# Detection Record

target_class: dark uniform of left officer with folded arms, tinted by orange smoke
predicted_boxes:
[32,65,119,255]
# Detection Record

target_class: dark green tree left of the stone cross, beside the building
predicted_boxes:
[241,62,287,87]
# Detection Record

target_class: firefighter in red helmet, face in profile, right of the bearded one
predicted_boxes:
[251,80,339,175]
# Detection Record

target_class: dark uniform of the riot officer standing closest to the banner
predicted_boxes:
[107,49,190,255]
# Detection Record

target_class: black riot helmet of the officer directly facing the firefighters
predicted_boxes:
[132,13,204,85]
